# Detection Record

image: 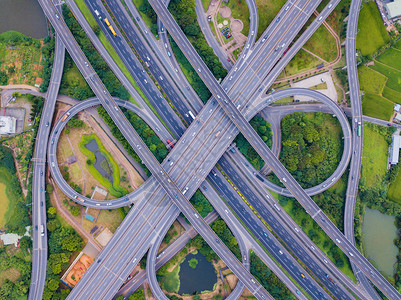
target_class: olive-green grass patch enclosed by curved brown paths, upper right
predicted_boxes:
[304,22,337,62]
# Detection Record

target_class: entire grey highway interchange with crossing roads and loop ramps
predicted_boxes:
[29,0,401,299]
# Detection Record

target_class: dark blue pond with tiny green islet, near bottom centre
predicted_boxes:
[178,252,217,295]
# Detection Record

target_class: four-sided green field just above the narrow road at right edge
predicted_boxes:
[362,93,394,121]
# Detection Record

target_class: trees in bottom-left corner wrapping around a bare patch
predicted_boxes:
[0,244,32,299]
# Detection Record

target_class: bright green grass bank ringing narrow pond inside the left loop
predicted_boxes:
[78,134,127,197]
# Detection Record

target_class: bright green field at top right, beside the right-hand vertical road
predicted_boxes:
[356,1,390,56]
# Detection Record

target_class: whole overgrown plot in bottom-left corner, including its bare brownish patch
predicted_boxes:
[0,245,32,299]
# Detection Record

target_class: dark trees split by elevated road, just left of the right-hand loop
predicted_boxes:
[234,116,272,170]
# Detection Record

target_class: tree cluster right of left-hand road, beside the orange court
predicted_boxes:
[43,203,83,300]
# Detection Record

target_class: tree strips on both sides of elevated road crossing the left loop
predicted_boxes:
[97,107,168,175]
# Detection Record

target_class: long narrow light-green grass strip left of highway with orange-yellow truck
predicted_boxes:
[75,0,146,104]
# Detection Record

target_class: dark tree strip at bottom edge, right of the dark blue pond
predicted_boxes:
[251,252,296,300]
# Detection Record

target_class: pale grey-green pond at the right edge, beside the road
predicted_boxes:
[362,208,397,276]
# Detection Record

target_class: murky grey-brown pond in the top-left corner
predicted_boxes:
[0,0,47,39]
